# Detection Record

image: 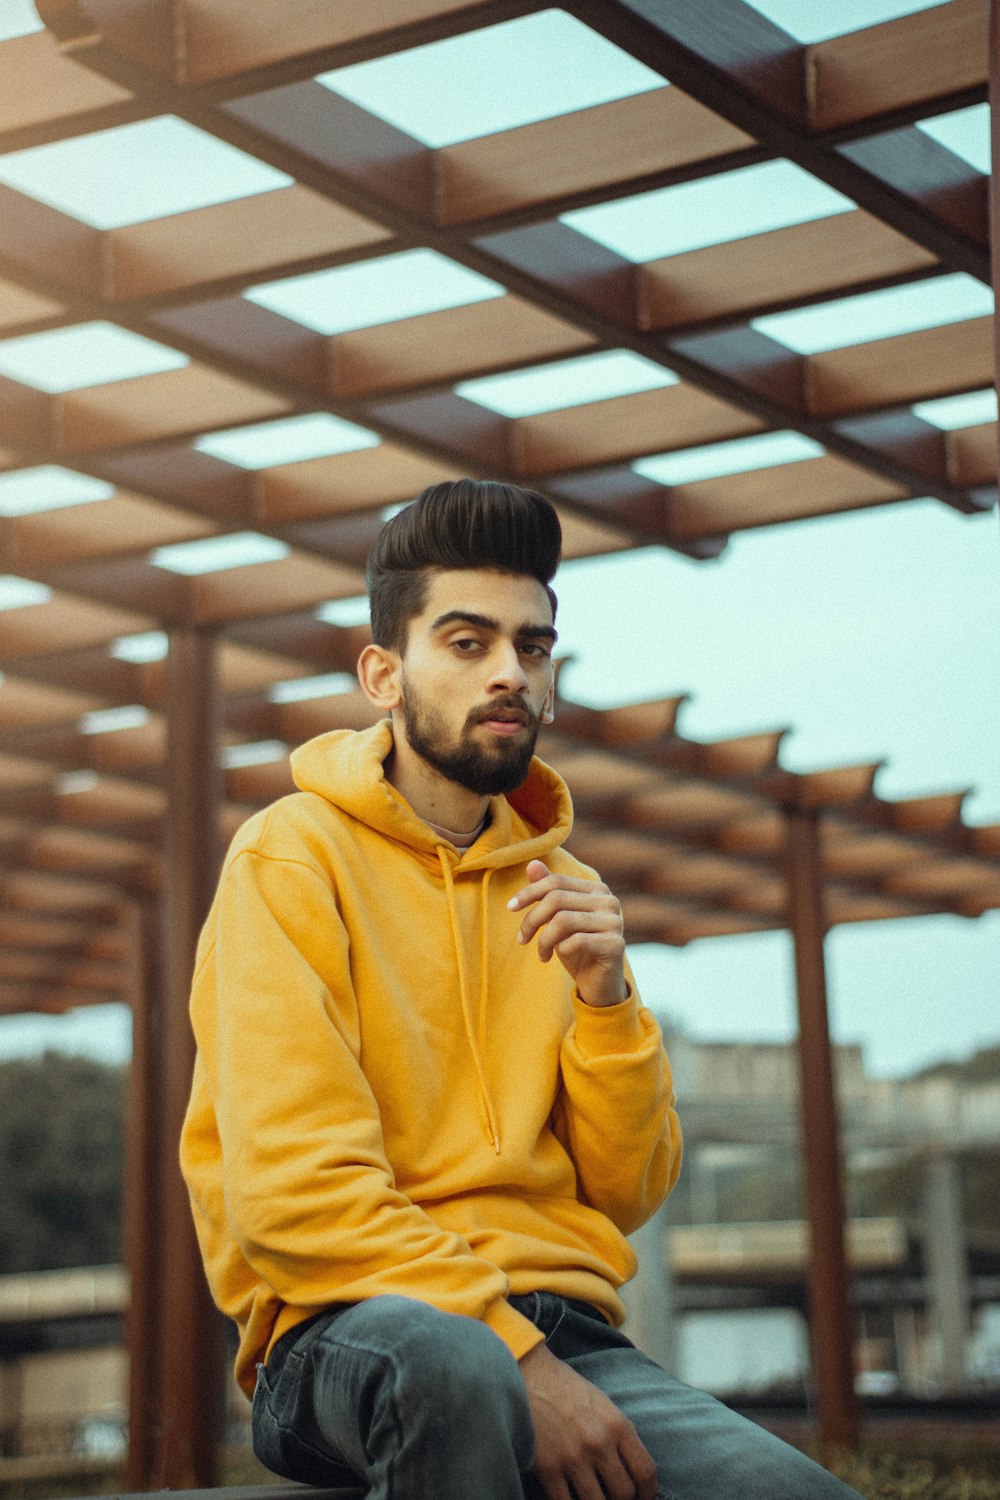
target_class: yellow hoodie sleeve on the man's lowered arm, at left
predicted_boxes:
[181,848,540,1358]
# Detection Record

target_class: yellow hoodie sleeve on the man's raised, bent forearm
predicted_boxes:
[556,975,681,1235]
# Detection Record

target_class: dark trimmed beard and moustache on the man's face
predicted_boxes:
[402,687,540,797]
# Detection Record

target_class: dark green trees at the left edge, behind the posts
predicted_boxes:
[0,1052,124,1272]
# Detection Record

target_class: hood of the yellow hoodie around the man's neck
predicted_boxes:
[291,719,573,870]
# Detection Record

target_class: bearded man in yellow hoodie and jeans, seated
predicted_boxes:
[181,480,850,1500]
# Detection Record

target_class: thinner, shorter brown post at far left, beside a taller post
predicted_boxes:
[120,902,162,1491]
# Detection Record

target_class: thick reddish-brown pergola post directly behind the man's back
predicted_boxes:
[156,627,223,1490]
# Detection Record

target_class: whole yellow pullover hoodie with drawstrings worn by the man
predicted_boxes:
[181,722,681,1394]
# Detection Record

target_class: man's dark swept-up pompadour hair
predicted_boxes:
[367,479,562,651]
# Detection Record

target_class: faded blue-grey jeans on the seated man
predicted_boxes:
[253,1292,858,1500]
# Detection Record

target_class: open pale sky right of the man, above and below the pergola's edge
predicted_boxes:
[559,500,1000,1077]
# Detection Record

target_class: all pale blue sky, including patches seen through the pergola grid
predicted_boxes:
[0,0,1000,1076]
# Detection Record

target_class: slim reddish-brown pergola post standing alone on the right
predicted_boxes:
[786,807,859,1448]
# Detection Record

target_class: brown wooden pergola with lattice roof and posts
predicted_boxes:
[0,0,1000,1490]
